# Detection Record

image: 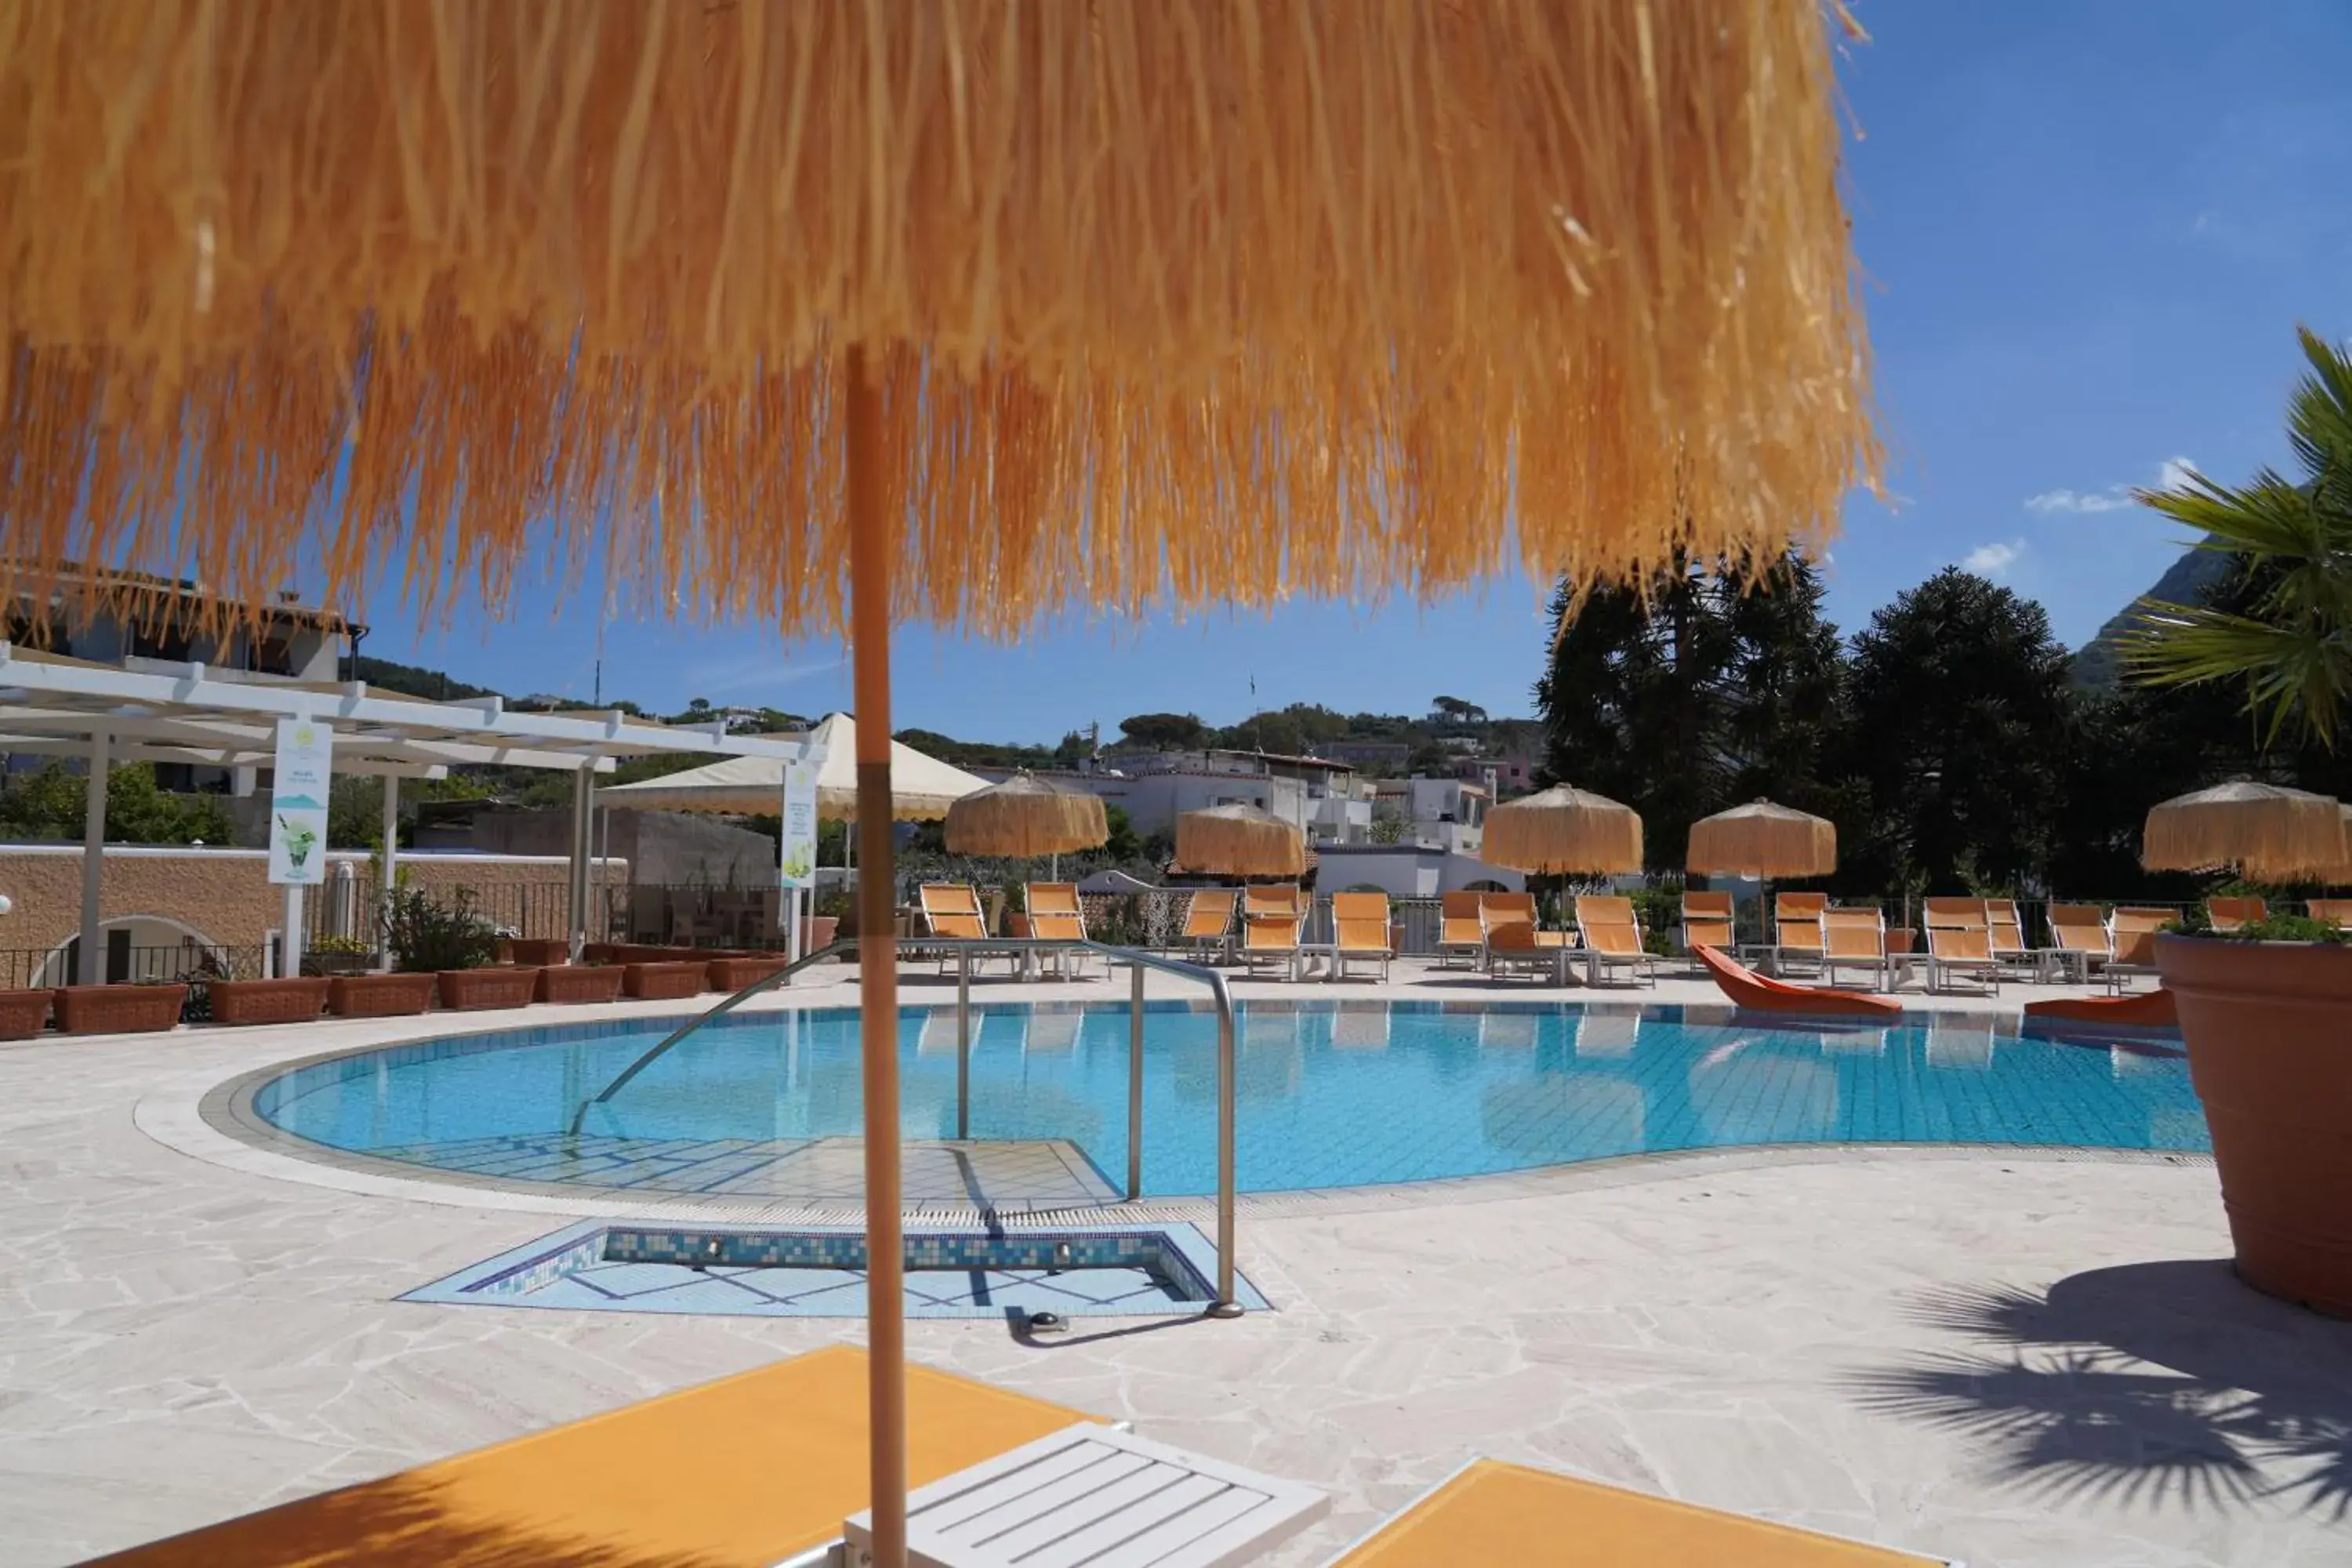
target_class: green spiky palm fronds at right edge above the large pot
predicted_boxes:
[2124,327,2352,750]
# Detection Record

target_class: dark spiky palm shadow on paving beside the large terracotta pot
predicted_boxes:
[1844,1260,2352,1521]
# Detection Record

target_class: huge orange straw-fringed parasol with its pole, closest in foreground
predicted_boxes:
[0,12,1877,1568]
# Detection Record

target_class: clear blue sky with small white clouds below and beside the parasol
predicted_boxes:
[353,0,2352,741]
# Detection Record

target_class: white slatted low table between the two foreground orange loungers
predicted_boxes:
[844,1422,1331,1568]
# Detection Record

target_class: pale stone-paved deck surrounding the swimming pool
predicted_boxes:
[0,968,2352,1568]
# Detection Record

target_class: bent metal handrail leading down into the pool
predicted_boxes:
[572,935,1242,1316]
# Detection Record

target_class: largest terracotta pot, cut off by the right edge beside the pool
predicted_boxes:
[2157,935,2352,1316]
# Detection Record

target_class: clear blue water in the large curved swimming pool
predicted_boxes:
[254,1004,2211,1194]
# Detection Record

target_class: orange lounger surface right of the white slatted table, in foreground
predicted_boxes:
[1331,1460,1945,1568]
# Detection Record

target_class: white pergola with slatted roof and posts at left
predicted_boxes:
[0,642,823,985]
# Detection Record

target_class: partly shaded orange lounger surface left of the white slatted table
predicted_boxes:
[82,1345,1094,1568]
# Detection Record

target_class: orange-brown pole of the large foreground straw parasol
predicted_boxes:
[842,348,906,1568]
